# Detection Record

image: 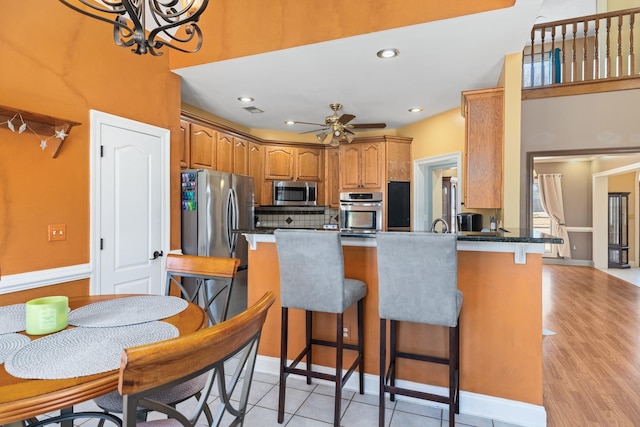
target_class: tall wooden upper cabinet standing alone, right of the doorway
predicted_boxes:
[462,88,504,209]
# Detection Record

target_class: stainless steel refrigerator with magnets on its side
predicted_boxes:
[182,169,254,318]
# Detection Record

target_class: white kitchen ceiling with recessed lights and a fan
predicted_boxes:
[175,0,595,136]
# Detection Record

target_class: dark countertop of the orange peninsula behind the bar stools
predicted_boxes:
[234,227,563,244]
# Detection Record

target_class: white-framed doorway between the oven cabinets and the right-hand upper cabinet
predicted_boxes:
[413,151,463,231]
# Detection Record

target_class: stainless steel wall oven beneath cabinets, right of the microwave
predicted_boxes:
[340,191,382,233]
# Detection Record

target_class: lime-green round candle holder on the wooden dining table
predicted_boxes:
[26,296,69,335]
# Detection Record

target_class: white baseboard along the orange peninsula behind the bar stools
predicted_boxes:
[255,356,547,427]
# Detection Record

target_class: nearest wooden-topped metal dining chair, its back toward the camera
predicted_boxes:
[118,292,275,427]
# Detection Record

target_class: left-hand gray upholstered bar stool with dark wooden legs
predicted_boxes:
[274,229,367,427]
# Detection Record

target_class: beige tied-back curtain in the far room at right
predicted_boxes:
[538,173,571,258]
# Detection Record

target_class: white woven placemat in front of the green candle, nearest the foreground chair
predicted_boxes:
[5,322,179,380]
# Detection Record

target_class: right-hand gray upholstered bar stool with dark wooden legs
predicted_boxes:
[376,232,462,427]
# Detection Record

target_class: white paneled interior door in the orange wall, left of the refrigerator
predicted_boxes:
[91,111,169,294]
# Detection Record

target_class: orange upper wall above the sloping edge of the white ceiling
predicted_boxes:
[171,0,515,69]
